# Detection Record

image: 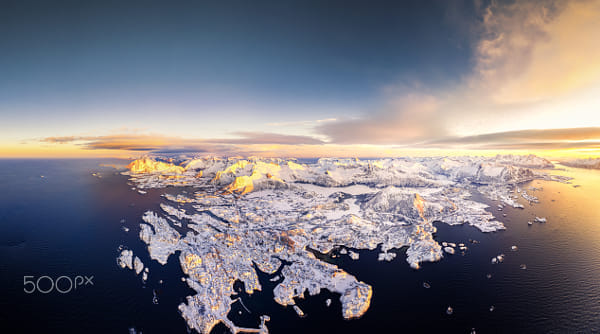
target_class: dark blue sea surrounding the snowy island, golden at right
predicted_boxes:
[0,160,600,334]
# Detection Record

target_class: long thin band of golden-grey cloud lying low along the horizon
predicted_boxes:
[34,127,600,157]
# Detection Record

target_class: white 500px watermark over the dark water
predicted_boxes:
[23,275,94,294]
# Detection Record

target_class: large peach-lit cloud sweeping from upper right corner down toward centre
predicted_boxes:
[315,0,600,146]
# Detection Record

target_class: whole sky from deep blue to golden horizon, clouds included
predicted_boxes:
[0,0,600,158]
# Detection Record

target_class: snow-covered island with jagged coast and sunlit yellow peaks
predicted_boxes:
[119,155,567,333]
